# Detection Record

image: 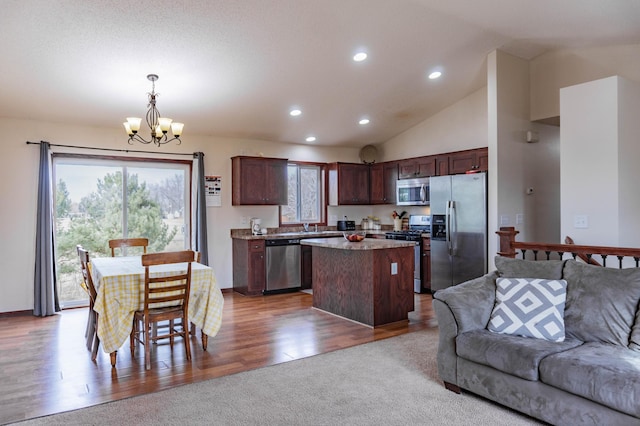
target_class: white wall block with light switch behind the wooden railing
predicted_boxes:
[560,77,640,247]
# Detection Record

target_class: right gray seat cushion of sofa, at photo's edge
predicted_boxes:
[540,343,640,417]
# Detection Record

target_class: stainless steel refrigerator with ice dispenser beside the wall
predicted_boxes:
[429,172,487,291]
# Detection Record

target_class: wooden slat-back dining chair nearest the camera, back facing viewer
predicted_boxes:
[130,250,195,370]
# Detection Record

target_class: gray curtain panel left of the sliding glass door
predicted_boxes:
[33,142,60,317]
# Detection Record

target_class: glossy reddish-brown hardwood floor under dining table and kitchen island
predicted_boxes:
[0,291,434,424]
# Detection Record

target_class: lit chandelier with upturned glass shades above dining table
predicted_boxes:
[122,74,184,146]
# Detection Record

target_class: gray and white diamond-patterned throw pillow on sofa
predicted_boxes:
[487,278,567,342]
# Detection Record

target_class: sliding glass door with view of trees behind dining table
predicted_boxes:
[53,155,191,307]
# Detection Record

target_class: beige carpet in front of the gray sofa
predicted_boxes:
[12,330,540,426]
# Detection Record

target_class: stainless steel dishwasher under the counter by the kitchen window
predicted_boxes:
[264,239,302,294]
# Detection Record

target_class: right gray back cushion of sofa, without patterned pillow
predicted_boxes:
[564,260,640,346]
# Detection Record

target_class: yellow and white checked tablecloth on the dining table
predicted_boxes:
[91,256,224,353]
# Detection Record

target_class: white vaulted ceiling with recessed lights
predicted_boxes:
[0,0,640,146]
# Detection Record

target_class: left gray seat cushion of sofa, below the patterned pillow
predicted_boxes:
[456,330,582,380]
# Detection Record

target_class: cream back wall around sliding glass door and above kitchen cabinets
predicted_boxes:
[0,118,360,312]
